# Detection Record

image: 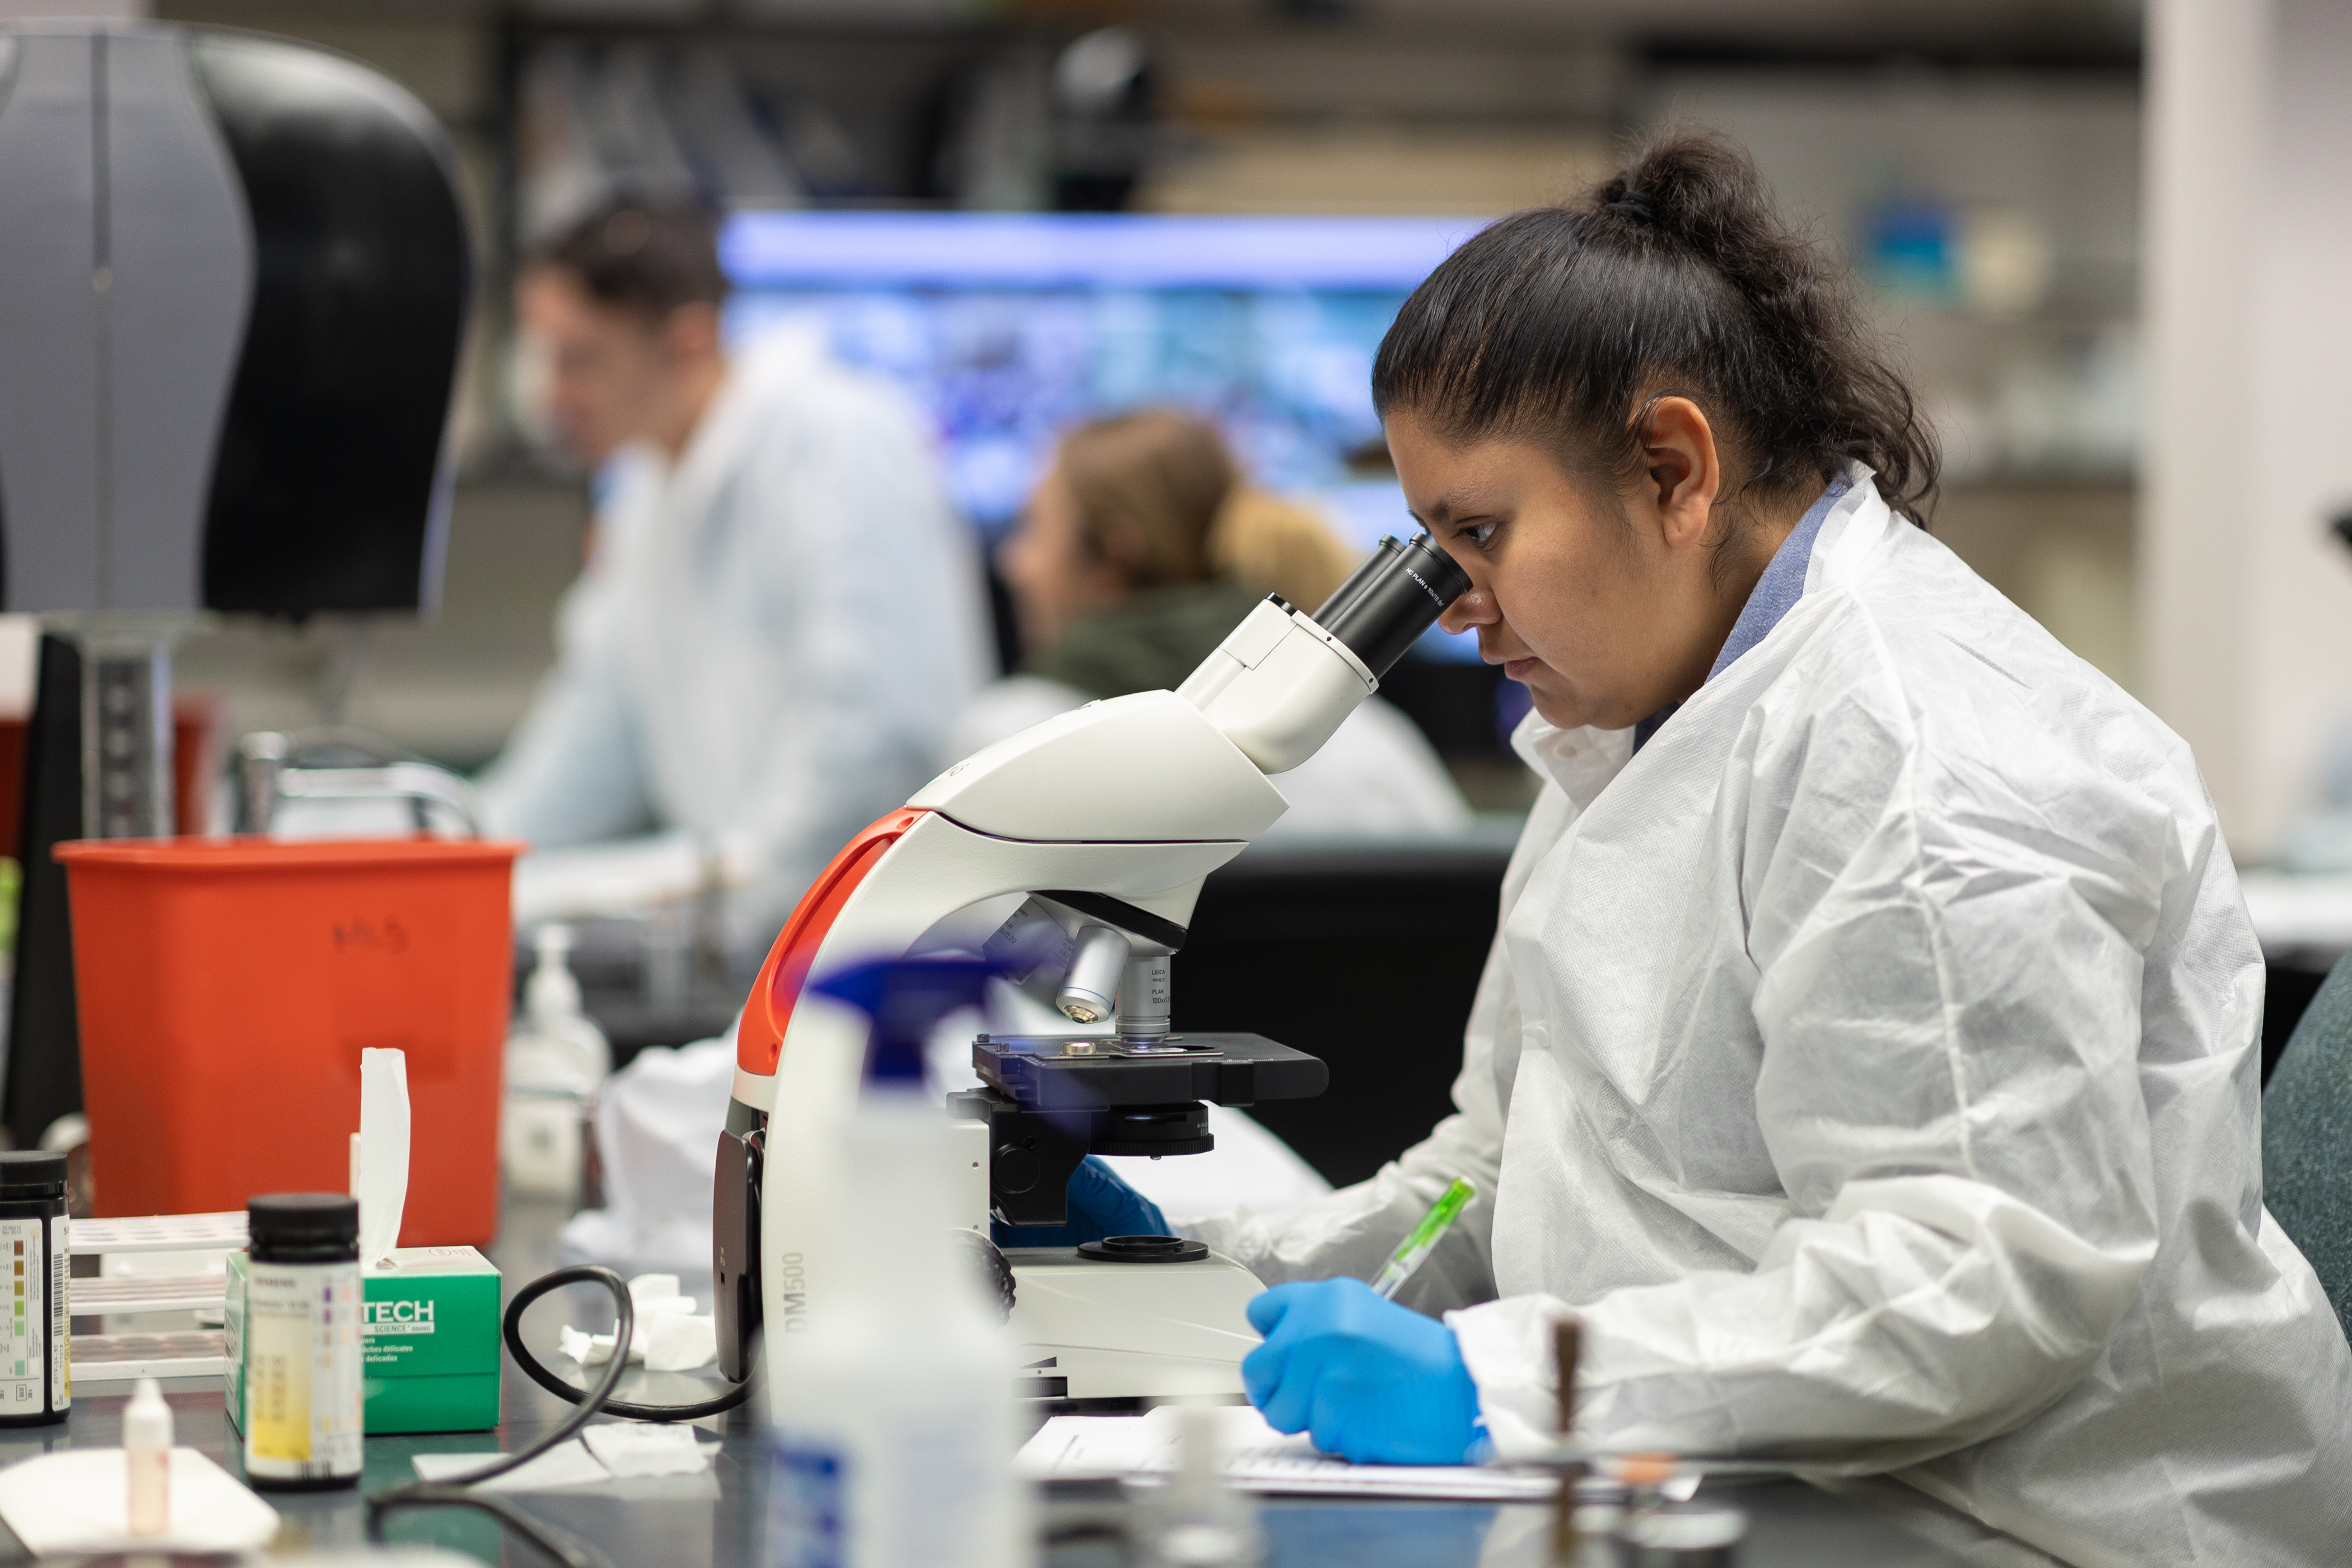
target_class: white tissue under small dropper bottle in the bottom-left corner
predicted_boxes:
[0,1448,278,1556]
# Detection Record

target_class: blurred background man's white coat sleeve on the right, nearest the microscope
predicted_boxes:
[722,383,983,945]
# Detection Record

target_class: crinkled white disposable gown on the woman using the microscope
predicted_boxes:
[1190,475,2352,1568]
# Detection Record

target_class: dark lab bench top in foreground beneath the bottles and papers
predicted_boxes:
[0,1378,1962,1568]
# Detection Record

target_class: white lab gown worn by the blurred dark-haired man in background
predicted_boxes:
[482,329,986,959]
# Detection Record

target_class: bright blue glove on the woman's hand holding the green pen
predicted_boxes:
[1242,1279,1477,1464]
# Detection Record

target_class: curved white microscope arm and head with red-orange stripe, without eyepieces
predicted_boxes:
[713,691,1286,1378]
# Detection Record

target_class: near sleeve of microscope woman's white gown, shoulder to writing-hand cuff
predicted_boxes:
[1449,679,2163,1474]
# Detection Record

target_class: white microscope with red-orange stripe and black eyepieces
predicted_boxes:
[713,534,1470,1401]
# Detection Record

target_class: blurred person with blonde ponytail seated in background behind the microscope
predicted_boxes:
[943,409,1470,839]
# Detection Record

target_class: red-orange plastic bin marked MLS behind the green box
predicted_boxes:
[57,837,525,1246]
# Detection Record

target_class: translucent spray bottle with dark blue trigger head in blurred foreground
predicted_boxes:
[764,962,1035,1568]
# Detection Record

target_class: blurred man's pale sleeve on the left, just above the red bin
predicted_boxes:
[480,564,654,848]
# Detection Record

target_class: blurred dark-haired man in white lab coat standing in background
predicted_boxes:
[482,204,986,964]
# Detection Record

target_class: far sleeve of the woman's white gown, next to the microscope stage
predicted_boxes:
[1183,785,1574,1312]
